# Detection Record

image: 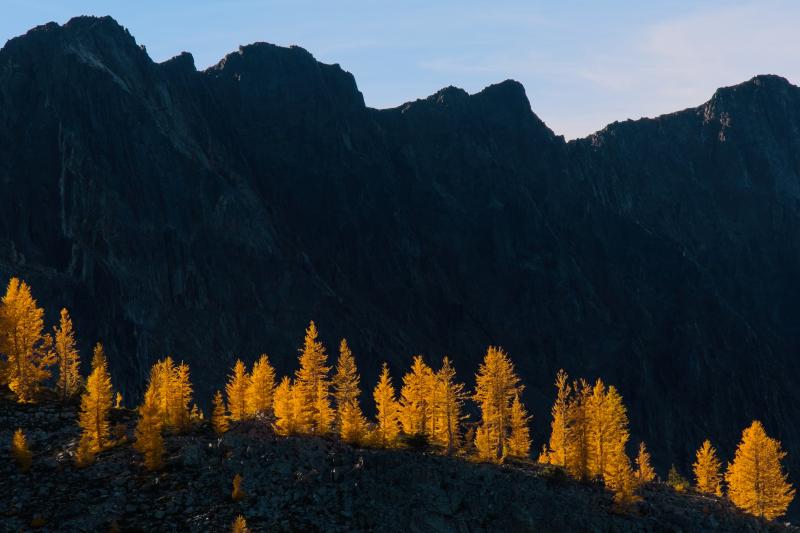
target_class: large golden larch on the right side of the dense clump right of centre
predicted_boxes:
[587,379,629,476]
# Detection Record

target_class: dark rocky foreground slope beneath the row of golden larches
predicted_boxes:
[0,392,796,532]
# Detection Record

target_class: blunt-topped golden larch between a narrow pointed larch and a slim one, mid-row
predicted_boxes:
[399,355,436,436]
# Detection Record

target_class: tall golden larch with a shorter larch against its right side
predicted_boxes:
[473,346,522,461]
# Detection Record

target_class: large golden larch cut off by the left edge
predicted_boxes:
[0,278,55,403]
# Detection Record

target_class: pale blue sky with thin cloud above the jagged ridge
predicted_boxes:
[0,0,800,139]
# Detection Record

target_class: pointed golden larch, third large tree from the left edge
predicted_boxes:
[78,342,113,453]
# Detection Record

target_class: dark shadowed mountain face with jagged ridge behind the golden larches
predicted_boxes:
[0,17,800,480]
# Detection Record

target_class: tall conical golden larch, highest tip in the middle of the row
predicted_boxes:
[294,320,333,435]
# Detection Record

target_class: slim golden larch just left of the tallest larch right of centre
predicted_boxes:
[431,356,467,454]
